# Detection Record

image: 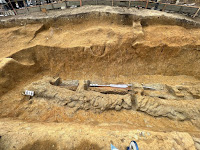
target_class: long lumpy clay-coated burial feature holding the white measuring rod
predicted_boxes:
[24,77,200,121]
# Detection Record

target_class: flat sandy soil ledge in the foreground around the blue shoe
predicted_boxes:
[0,119,198,150]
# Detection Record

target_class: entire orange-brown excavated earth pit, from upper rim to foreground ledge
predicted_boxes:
[0,6,200,150]
